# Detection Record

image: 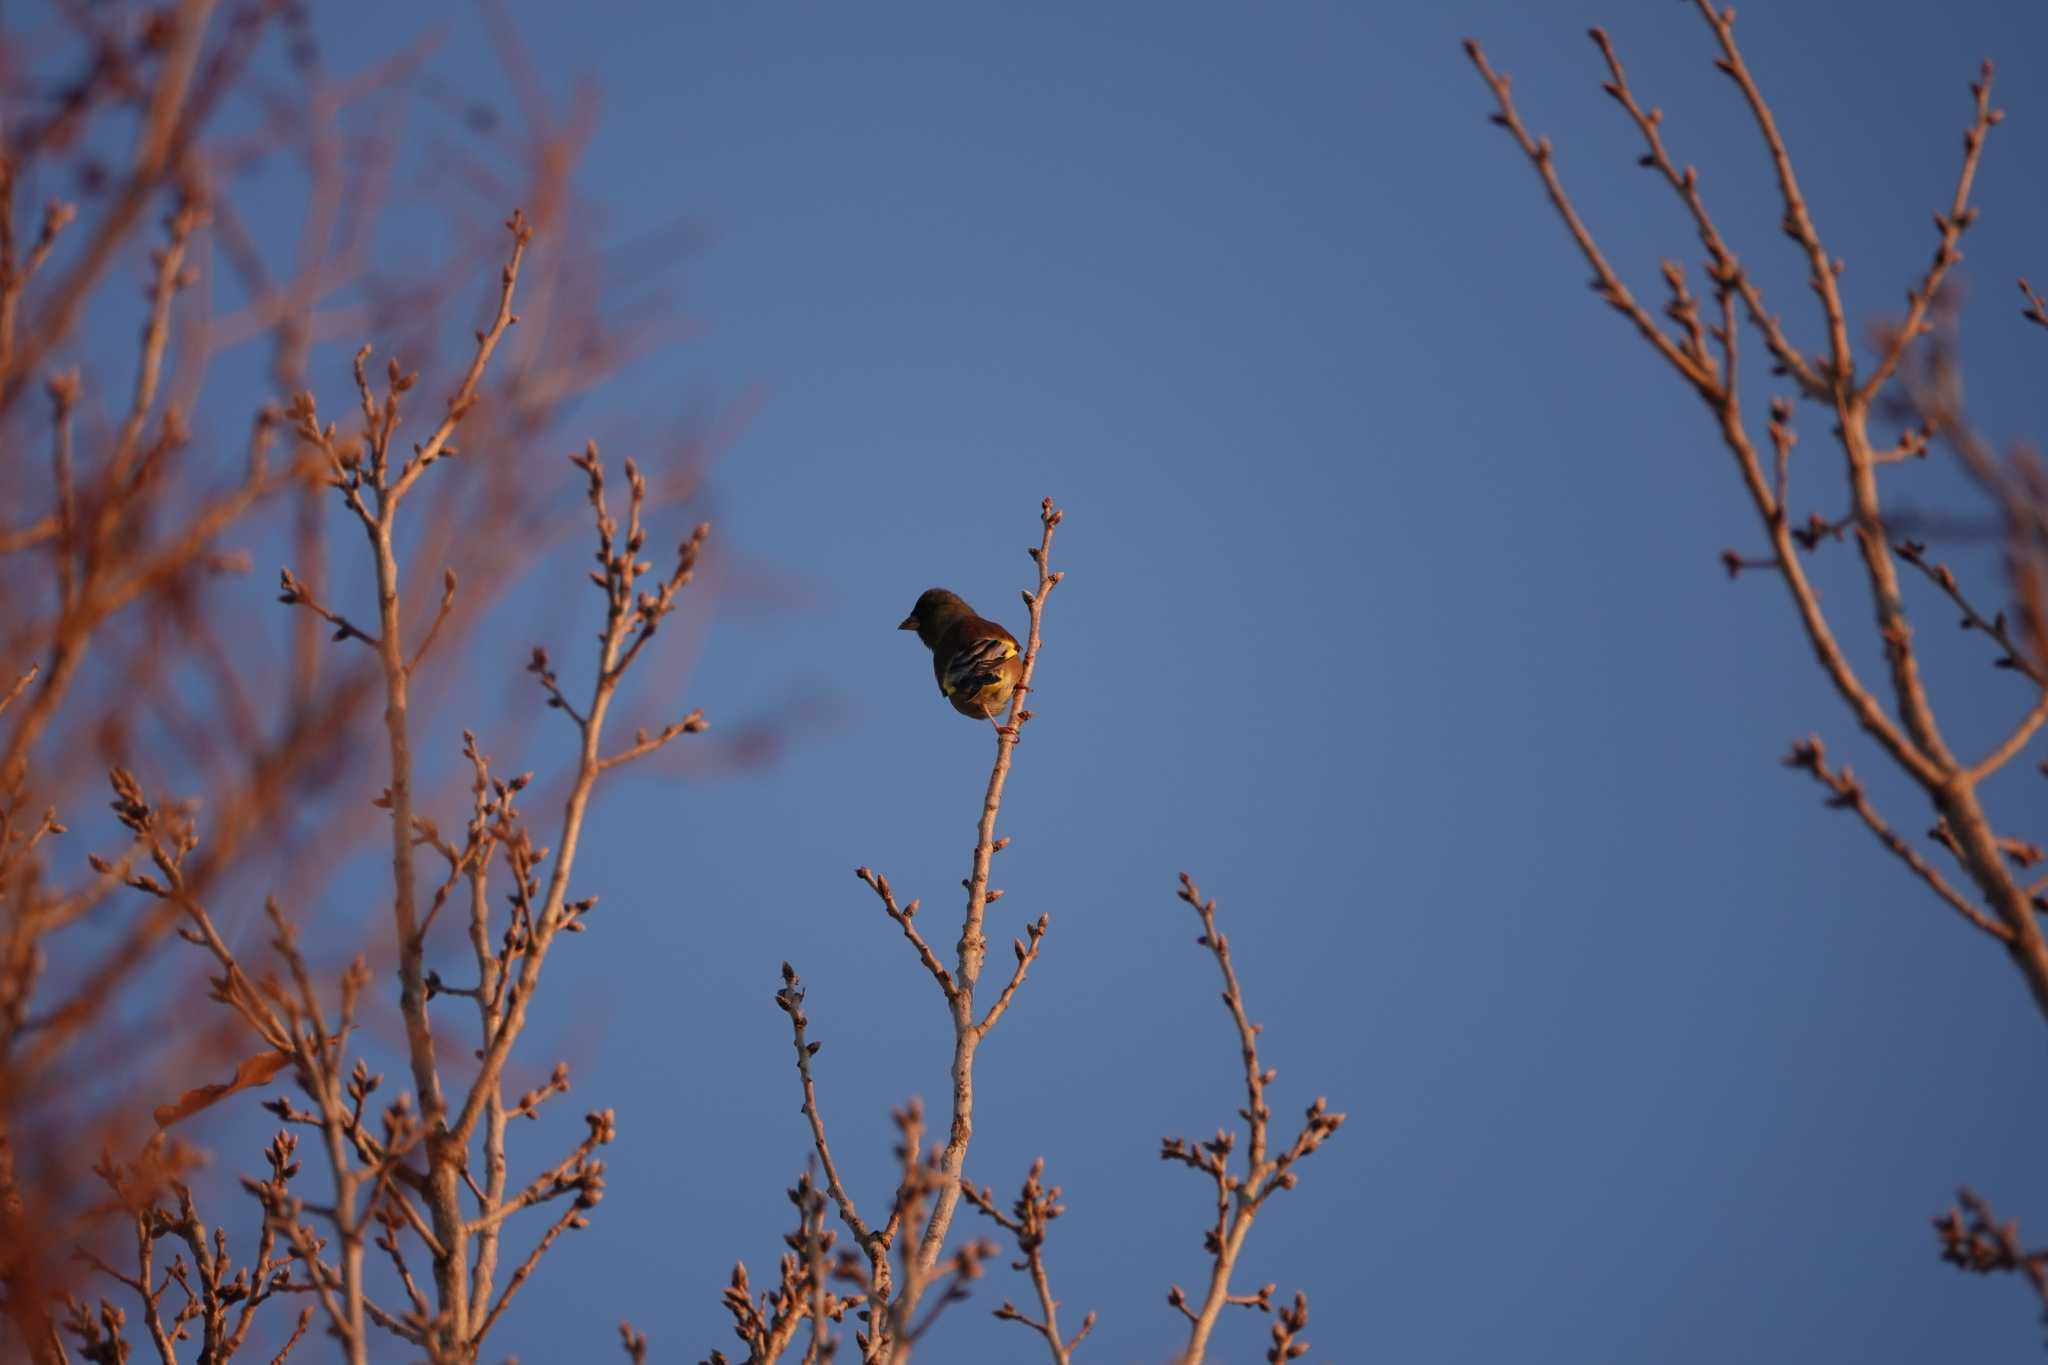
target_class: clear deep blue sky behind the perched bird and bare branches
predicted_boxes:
[163,0,2048,1363]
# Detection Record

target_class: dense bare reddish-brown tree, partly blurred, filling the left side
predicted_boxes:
[0,0,733,1361]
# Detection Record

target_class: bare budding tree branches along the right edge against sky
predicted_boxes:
[1466,0,2048,1342]
